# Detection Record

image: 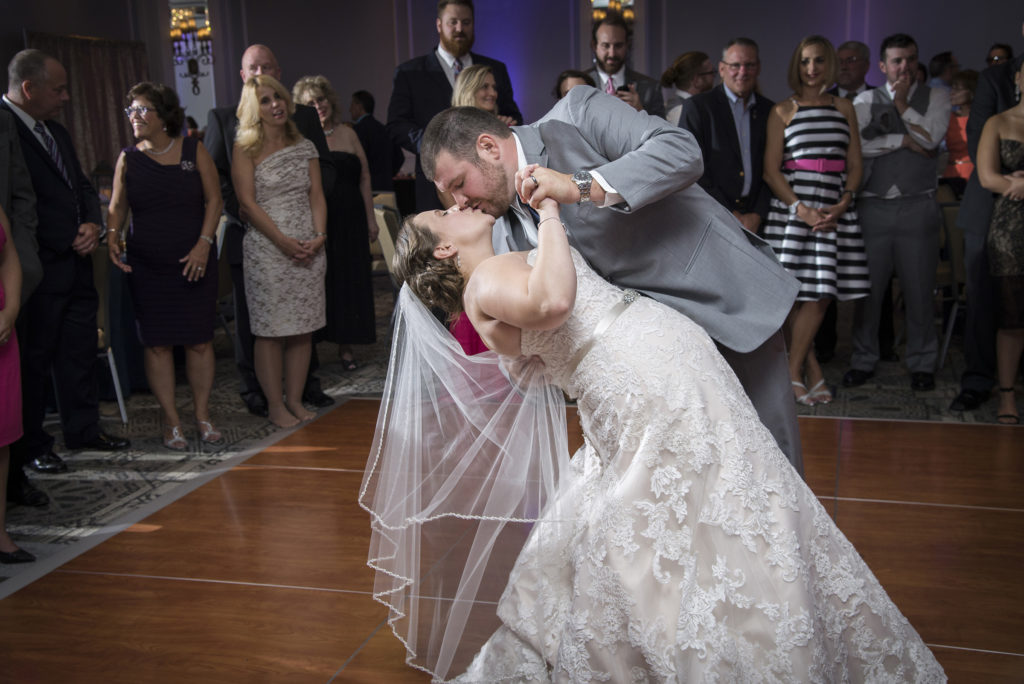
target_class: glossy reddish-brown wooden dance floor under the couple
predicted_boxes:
[0,399,1024,684]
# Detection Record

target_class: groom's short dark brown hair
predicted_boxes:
[420,106,512,181]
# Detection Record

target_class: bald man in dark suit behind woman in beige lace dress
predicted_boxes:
[203,44,335,418]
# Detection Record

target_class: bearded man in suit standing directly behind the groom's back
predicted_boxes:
[587,11,665,118]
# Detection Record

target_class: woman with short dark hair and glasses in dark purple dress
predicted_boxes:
[108,83,223,451]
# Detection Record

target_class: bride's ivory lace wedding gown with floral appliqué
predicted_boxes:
[458,248,945,682]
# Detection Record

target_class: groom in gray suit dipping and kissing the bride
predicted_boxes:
[421,87,803,475]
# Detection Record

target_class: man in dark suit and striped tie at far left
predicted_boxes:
[2,50,129,485]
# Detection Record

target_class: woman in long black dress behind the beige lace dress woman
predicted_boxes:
[292,76,377,371]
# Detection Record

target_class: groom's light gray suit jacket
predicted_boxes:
[513,86,799,353]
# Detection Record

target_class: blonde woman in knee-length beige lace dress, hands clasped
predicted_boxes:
[231,75,327,427]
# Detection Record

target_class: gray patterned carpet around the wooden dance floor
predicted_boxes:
[0,275,1015,598]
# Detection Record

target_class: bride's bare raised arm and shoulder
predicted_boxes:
[465,192,577,330]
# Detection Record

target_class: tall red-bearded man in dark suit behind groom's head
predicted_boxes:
[387,0,522,211]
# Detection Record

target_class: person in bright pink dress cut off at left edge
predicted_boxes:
[0,207,36,564]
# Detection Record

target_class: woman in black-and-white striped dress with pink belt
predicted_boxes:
[764,36,869,405]
